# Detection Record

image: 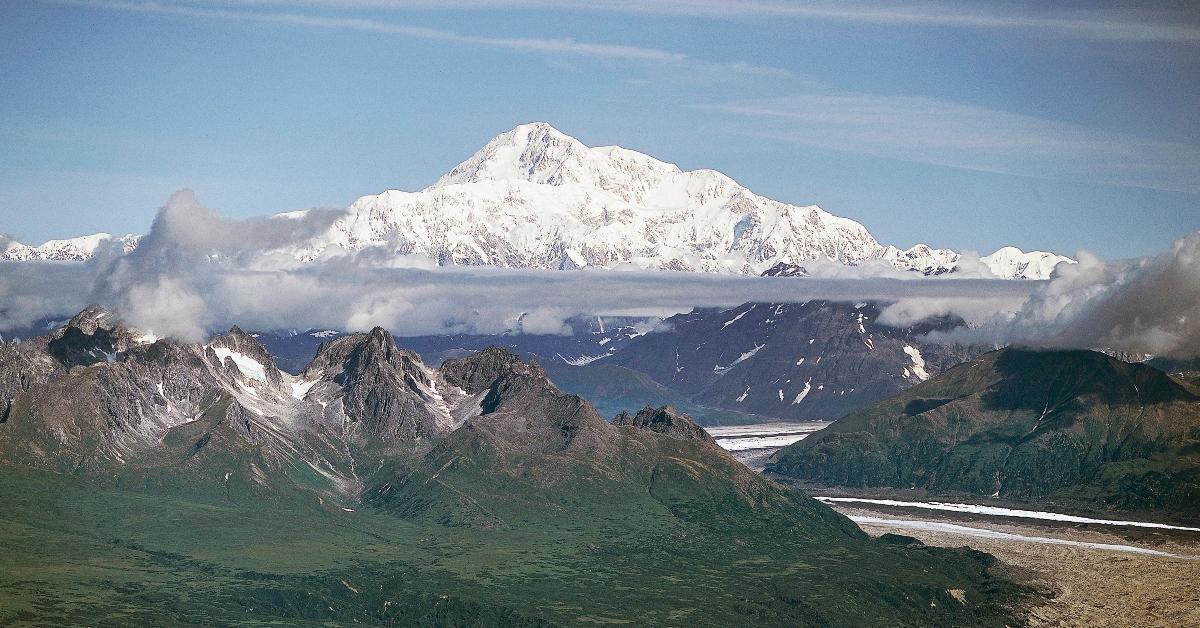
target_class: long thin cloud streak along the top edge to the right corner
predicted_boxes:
[187,0,1200,44]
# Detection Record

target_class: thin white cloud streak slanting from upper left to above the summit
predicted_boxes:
[47,0,792,76]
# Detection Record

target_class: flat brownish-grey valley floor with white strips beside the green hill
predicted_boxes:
[709,425,1200,627]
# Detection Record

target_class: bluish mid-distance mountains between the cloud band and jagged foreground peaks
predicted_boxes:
[236,300,992,425]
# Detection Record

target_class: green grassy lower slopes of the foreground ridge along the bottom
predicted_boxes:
[0,453,1032,626]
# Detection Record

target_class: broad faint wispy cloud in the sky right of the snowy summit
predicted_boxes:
[697,92,1200,193]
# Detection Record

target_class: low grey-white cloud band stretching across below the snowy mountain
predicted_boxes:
[0,191,1200,355]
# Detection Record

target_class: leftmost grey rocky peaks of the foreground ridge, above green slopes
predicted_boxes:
[0,307,354,495]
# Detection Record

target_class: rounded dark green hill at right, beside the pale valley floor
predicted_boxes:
[768,348,1200,521]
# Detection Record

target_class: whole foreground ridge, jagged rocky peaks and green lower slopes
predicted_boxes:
[0,309,1030,626]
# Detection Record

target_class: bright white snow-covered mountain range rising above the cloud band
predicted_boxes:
[0,122,1070,279]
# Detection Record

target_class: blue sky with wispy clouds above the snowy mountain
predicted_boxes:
[0,0,1200,258]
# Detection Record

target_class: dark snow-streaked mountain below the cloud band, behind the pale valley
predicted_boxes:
[606,301,986,420]
